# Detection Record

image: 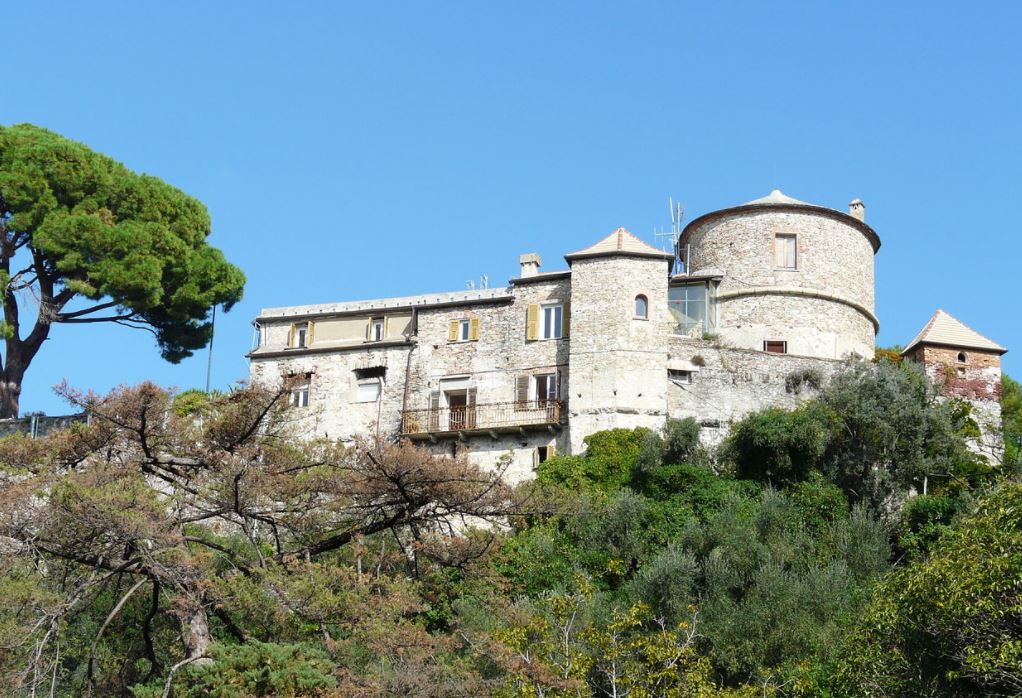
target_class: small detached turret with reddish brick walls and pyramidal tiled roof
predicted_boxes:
[901,310,1008,462]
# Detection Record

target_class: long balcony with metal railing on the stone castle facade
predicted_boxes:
[401,400,563,441]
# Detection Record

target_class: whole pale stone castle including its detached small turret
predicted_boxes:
[248,190,1006,480]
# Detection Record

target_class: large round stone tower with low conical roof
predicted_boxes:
[678,189,880,359]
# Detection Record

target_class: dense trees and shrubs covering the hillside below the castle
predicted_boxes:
[0,362,1022,698]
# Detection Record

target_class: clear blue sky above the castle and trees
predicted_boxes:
[0,0,1022,414]
